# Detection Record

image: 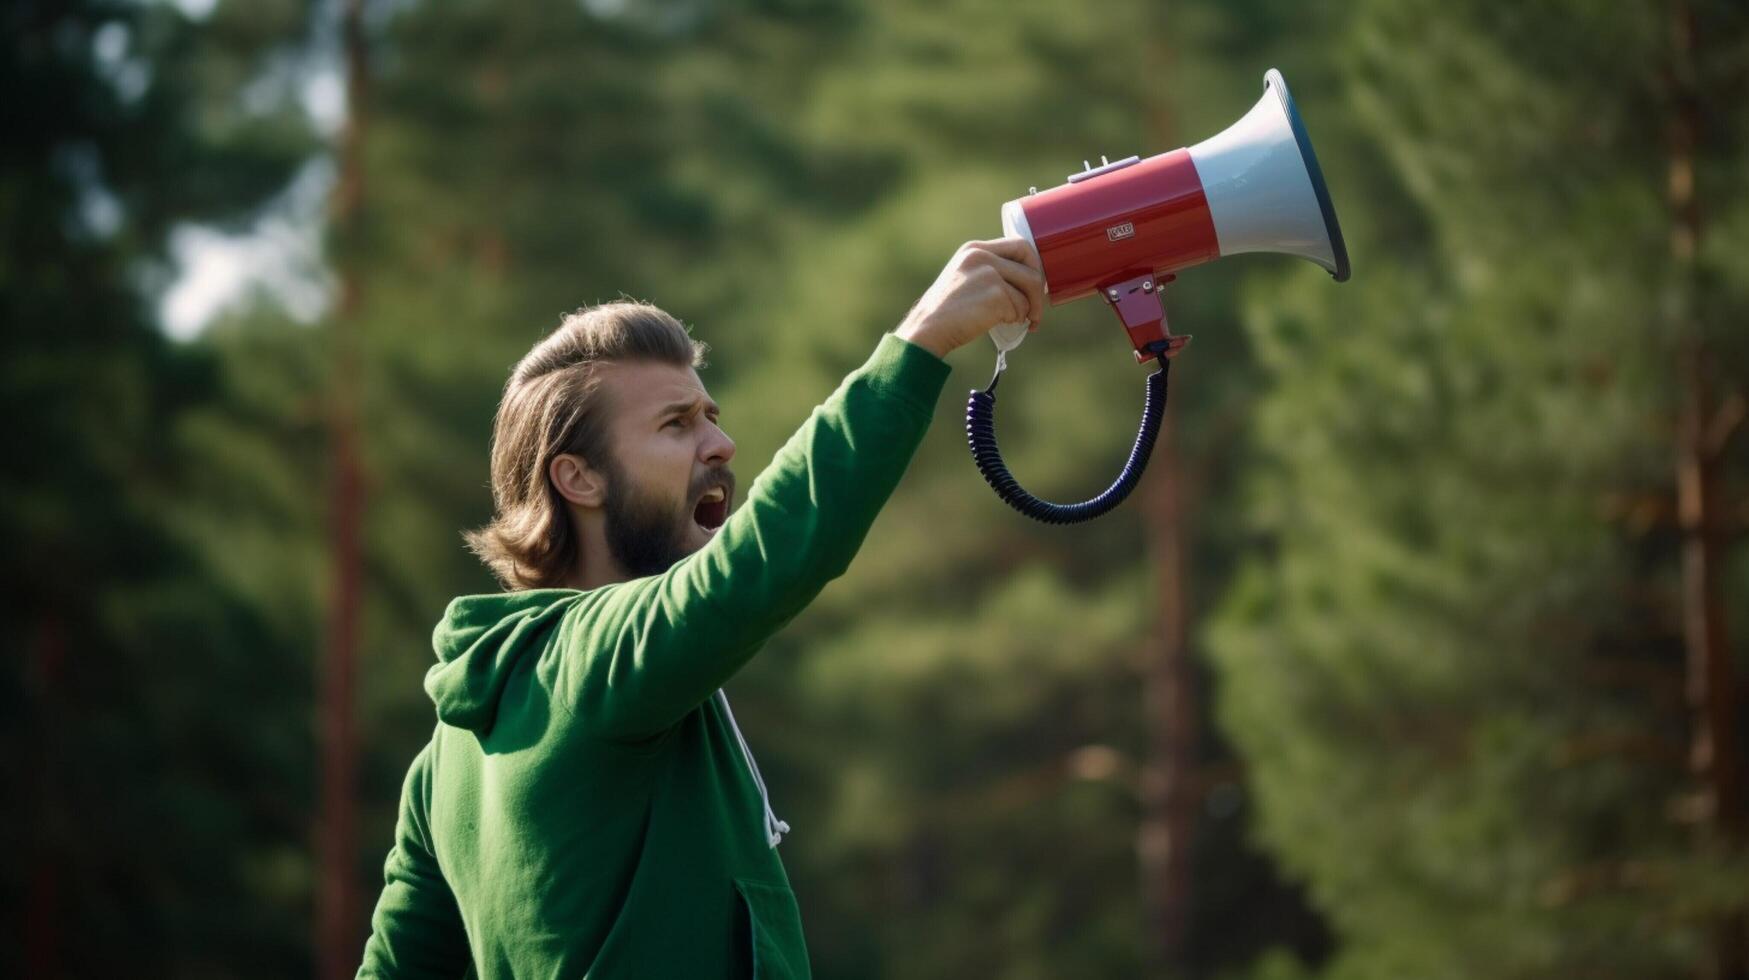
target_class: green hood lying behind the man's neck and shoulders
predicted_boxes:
[425,588,582,735]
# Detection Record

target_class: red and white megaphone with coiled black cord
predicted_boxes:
[965,68,1348,523]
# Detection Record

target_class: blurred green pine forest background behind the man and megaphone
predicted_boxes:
[0,0,1749,980]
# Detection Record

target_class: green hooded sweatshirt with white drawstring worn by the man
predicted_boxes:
[359,334,948,980]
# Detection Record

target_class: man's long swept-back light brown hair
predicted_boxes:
[462,301,707,590]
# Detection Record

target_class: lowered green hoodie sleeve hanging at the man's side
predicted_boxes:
[359,744,472,980]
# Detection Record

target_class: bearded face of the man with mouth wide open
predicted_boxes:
[602,362,735,578]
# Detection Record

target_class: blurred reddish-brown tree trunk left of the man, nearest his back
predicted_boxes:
[317,0,367,980]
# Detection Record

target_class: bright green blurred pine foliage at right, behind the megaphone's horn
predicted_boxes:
[1214,4,1749,978]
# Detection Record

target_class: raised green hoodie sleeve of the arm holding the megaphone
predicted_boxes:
[556,334,948,739]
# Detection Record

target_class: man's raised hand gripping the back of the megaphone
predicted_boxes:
[894,238,1044,357]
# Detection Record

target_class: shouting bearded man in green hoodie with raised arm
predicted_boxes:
[359,238,1044,980]
